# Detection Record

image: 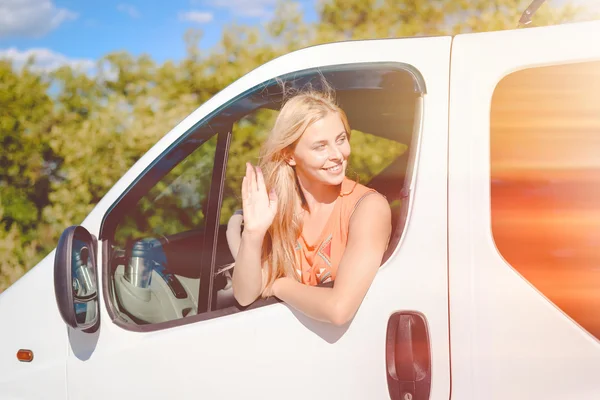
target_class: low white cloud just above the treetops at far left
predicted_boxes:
[0,47,96,74]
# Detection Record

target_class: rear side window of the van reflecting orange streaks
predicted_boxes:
[490,62,600,338]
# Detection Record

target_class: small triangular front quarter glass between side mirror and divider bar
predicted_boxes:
[110,135,217,324]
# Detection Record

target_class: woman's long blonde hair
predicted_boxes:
[259,82,350,287]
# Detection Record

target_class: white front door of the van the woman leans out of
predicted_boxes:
[67,37,451,400]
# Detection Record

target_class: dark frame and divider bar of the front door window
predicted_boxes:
[99,61,427,332]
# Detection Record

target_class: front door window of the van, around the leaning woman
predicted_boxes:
[100,64,422,331]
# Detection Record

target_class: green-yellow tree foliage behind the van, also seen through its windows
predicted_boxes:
[0,0,590,292]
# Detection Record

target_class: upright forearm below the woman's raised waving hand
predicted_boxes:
[232,231,265,306]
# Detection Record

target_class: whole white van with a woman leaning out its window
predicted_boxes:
[0,17,600,400]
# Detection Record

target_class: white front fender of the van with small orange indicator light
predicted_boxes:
[0,251,68,400]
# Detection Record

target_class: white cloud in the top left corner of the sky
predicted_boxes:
[0,0,78,38]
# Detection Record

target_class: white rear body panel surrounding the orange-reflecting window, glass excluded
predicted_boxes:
[448,21,600,400]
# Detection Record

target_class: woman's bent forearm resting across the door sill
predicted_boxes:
[273,278,354,326]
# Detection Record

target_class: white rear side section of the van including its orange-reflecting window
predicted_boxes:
[449,21,600,399]
